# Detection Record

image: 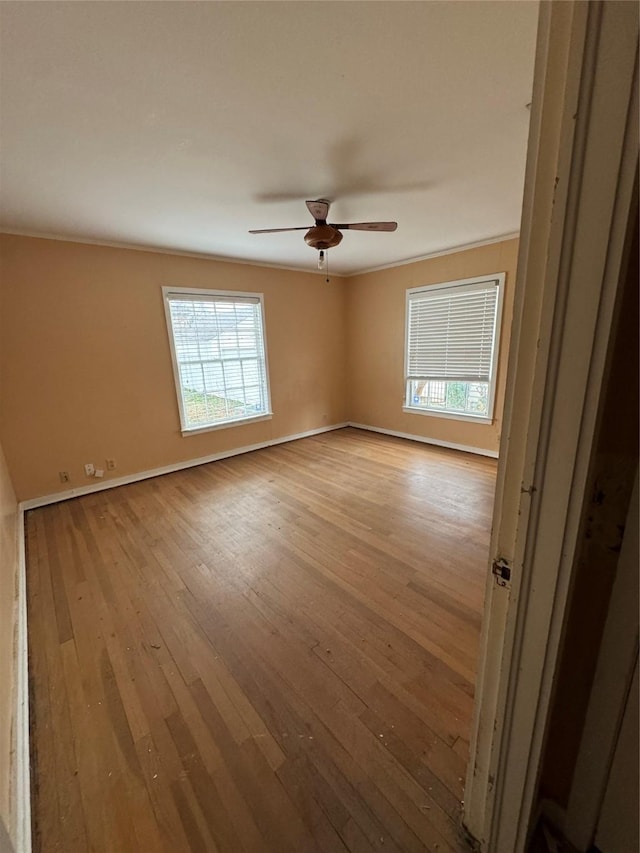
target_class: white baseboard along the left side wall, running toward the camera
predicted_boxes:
[14,507,31,853]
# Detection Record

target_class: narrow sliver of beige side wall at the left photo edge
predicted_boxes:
[0,447,18,847]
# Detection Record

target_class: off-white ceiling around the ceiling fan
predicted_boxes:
[0,0,538,274]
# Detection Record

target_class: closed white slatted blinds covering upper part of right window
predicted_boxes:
[407,279,499,382]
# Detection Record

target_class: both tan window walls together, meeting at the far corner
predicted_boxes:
[0,235,517,500]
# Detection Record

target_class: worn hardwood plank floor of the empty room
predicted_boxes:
[26,429,496,853]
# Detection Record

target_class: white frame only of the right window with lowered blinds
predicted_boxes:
[402,272,506,424]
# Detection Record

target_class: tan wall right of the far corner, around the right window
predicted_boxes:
[347,239,518,451]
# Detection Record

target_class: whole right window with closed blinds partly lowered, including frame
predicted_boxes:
[404,273,504,421]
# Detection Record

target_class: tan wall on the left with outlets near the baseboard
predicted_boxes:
[0,235,346,500]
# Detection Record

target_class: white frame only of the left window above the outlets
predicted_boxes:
[162,287,273,437]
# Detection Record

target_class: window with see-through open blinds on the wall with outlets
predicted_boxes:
[163,287,271,434]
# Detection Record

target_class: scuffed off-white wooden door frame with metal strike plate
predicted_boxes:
[463,0,638,853]
